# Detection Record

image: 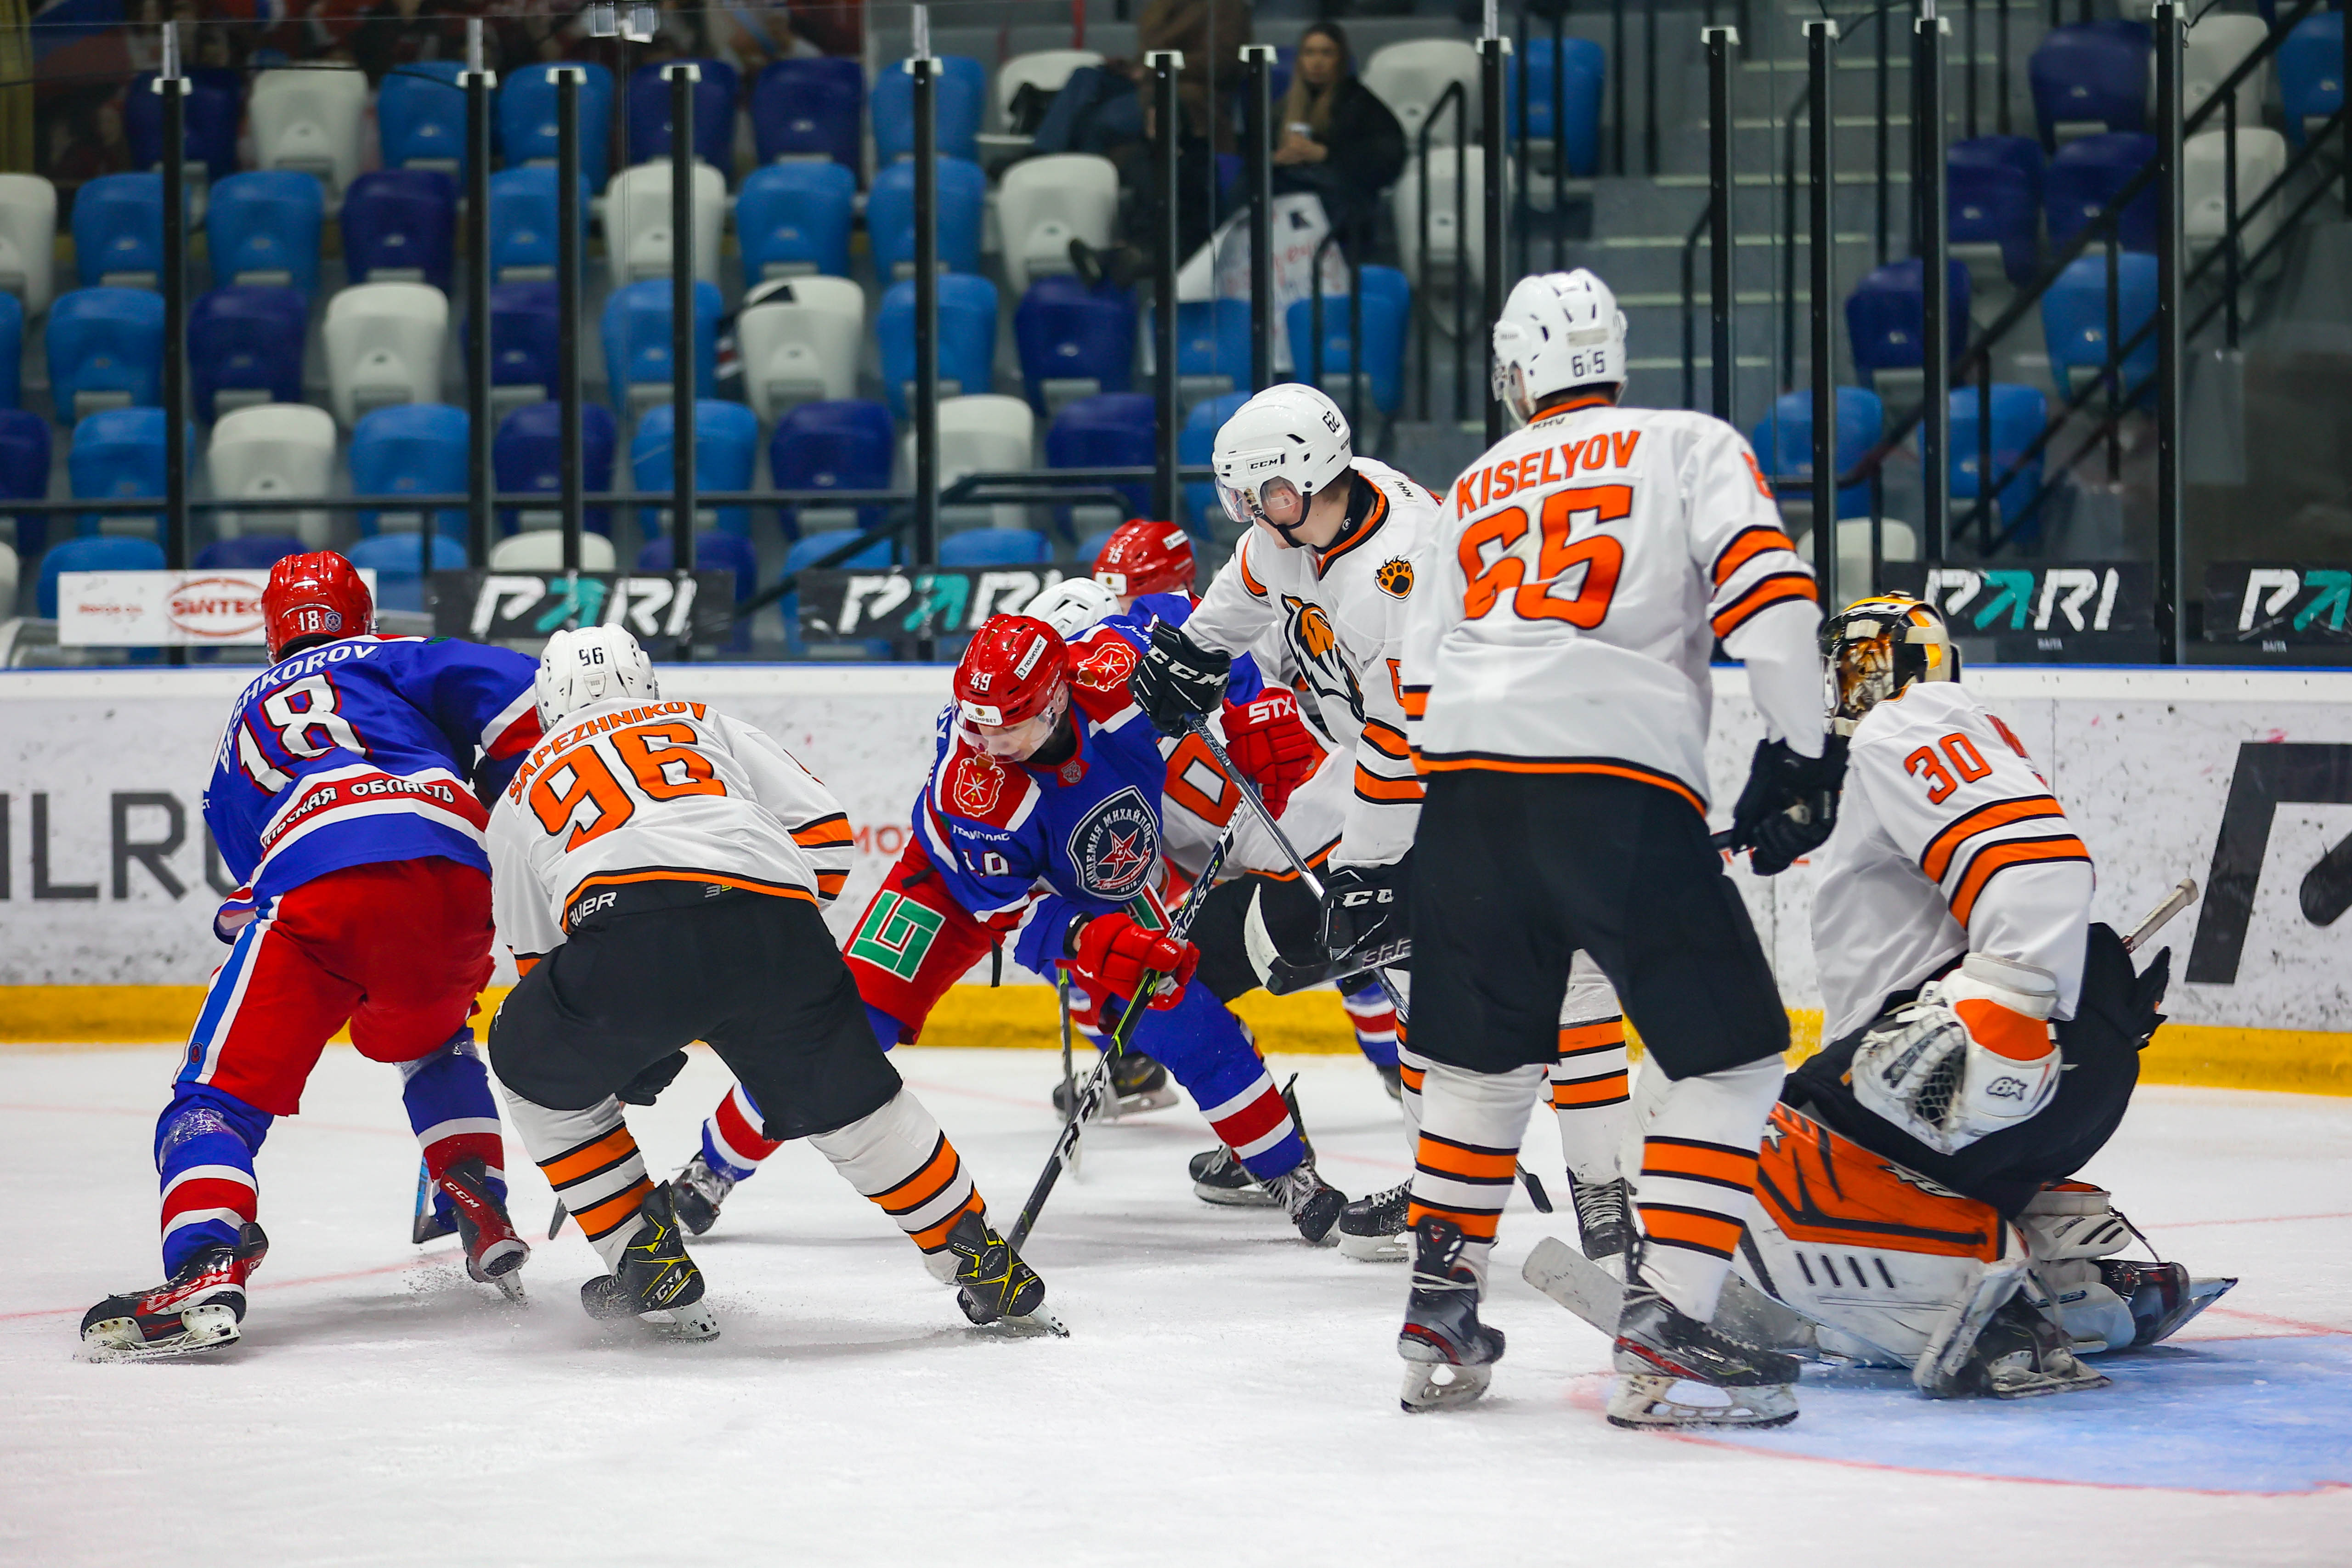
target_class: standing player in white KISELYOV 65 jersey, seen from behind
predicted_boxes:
[1397,270,1842,1427]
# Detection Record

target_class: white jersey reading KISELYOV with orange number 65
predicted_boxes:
[1404,397,1823,811]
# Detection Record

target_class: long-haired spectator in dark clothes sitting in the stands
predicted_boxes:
[1272,21,1404,254]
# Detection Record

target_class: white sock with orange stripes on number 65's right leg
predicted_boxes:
[1632,1056,1785,1324]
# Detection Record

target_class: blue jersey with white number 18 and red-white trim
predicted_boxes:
[204,637,538,914]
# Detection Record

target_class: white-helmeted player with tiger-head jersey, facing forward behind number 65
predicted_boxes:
[1131,383,1625,1260]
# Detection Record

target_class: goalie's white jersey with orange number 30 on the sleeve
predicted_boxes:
[1814,682,2093,1039]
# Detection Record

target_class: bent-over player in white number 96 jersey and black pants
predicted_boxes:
[489,625,1044,1338]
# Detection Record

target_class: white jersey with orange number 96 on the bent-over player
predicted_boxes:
[489,701,854,959]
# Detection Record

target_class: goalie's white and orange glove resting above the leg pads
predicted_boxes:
[1851,952,2065,1154]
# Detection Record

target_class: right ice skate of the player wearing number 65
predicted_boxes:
[1609,1274,1797,1427]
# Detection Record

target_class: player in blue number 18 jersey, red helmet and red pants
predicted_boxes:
[82,552,538,1359]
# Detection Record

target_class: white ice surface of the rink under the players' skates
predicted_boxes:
[0,1048,2352,1568]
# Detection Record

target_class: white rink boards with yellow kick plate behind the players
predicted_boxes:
[0,665,2352,1093]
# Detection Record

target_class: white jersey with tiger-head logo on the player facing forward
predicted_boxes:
[1183,459,1437,865]
